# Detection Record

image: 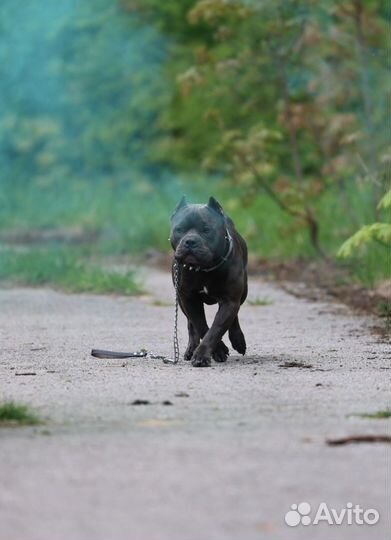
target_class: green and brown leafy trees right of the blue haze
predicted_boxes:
[139,0,391,255]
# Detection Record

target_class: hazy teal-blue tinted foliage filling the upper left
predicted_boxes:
[0,0,169,191]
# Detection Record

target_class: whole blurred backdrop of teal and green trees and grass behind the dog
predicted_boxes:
[0,0,391,294]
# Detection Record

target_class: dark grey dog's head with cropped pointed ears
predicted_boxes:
[170,197,227,268]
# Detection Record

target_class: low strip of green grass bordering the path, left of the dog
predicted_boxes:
[0,247,141,295]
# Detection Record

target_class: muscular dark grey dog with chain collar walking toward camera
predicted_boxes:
[170,197,247,367]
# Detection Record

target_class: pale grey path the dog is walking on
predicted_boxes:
[0,270,391,540]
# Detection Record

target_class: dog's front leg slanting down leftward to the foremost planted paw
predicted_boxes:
[192,300,240,367]
